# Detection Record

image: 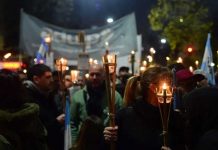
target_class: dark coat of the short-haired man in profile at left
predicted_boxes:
[23,82,64,150]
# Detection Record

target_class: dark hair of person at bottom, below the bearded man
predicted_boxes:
[75,115,104,150]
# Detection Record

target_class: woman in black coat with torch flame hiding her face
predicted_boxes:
[104,67,182,150]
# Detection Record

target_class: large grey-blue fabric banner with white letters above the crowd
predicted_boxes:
[19,11,137,60]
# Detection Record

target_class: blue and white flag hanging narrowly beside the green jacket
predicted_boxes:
[64,96,72,150]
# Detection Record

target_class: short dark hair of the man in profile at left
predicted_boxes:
[27,64,51,81]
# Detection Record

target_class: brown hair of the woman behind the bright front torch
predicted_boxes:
[140,67,172,96]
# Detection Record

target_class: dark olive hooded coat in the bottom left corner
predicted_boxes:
[0,103,47,150]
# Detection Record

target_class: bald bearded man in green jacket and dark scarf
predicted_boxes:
[71,64,122,143]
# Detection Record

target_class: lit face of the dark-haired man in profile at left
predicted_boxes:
[33,71,53,91]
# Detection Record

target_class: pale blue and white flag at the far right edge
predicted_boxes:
[201,33,215,85]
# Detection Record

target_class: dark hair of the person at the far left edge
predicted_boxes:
[0,69,24,109]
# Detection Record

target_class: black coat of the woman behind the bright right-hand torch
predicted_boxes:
[116,99,184,150]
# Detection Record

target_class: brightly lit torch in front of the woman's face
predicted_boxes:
[156,83,172,147]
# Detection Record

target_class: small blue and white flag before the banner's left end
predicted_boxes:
[36,38,48,64]
